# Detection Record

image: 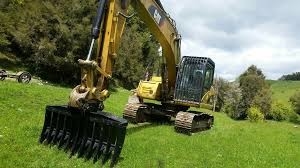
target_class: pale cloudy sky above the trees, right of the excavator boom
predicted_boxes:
[161,0,300,80]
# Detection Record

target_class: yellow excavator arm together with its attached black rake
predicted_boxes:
[39,0,180,164]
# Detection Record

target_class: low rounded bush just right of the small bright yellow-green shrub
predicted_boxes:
[267,102,293,121]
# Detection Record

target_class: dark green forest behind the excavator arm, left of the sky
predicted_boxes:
[0,0,159,89]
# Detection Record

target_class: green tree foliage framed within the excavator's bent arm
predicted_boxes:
[114,9,159,89]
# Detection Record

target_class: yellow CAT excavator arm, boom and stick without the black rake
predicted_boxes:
[69,0,181,109]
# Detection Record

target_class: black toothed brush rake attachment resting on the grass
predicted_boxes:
[39,106,128,166]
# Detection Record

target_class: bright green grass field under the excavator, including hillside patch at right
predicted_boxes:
[0,81,300,168]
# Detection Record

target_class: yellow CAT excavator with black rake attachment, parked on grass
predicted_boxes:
[39,0,215,165]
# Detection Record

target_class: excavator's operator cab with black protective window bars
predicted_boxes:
[174,56,215,106]
